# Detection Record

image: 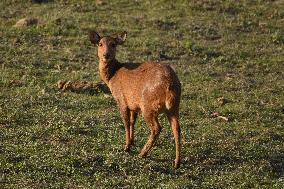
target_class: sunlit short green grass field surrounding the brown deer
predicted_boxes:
[0,0,284,189]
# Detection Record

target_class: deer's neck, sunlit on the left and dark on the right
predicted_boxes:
[99,59,121,85]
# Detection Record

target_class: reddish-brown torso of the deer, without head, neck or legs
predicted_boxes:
[109,62,180,111]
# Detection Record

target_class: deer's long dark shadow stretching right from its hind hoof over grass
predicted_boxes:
[180,150,284,178]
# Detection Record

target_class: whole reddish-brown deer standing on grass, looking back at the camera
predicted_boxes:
[89,32,181,168]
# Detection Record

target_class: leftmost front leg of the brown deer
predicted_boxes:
[120,107,131,152]
